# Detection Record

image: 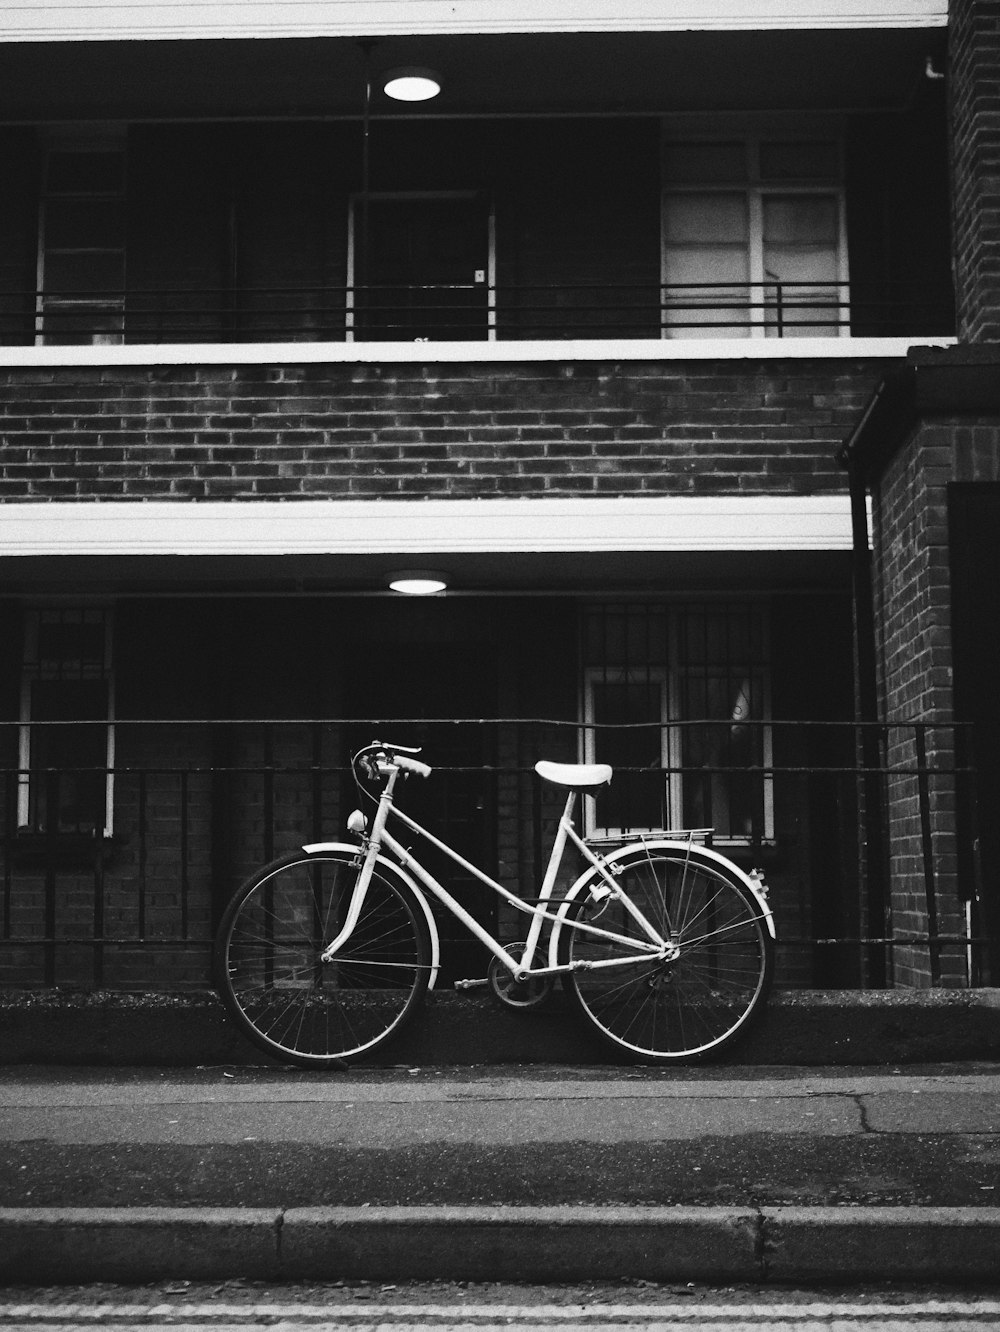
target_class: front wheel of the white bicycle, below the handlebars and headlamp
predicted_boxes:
[214,847,430,1068]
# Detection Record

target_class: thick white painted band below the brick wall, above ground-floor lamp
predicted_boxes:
[0,494,851,557]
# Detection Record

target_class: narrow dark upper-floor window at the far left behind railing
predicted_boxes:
[36,137,125,344]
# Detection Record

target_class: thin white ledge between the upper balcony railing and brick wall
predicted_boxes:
[0,337,956,369]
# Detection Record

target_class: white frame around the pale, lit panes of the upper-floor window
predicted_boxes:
[660,125,851,340]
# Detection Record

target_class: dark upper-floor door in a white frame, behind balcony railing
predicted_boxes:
[354,194,489,342]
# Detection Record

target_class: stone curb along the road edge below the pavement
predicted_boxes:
[0,1207,1000,1285]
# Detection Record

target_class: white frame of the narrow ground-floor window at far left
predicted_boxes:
[17,603,116,840]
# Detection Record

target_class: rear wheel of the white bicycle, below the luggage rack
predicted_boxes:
[563,847,774,1063]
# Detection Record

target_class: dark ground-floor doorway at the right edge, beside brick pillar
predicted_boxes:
[948,482,1000,986]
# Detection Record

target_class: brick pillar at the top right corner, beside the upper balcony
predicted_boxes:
[948,0,1000,342]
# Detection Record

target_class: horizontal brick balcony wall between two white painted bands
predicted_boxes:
[0,361,884,501]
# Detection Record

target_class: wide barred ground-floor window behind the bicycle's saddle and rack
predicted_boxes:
[582,605,774,842]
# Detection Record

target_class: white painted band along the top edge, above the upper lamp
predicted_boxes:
[0,0,948,43]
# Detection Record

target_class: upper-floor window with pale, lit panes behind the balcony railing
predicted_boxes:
[662,136,848,337]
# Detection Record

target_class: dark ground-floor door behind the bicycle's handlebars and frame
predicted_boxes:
[346,641,497,983]
